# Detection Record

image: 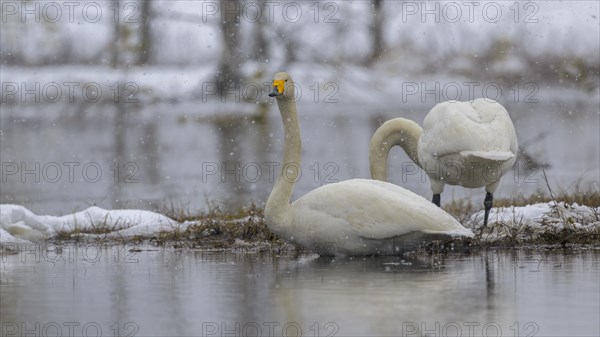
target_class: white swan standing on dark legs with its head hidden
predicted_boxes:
[369,98,518,227]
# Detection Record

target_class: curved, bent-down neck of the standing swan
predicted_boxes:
[369,118,423,181]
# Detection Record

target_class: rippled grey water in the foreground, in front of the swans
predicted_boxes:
[0,246,600,336]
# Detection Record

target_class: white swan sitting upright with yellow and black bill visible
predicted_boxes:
[265,73,473,255]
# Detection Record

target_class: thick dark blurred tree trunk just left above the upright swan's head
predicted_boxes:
[215,0,242,95]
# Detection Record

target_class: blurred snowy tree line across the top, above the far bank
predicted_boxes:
[0,0,600,89]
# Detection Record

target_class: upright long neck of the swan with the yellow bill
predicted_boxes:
[265,97,301,226]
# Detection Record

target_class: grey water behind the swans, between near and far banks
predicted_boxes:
[0,97,600,215]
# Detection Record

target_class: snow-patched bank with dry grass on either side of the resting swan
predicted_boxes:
[0,202,600,246]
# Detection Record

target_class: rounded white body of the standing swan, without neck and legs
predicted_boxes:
[417,98,517,190]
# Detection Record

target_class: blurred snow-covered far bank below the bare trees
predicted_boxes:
[0,59,598,111]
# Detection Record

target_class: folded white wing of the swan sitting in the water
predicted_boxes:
[292,179,473,239]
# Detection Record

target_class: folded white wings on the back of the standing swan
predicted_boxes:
[418,99,517,159]
